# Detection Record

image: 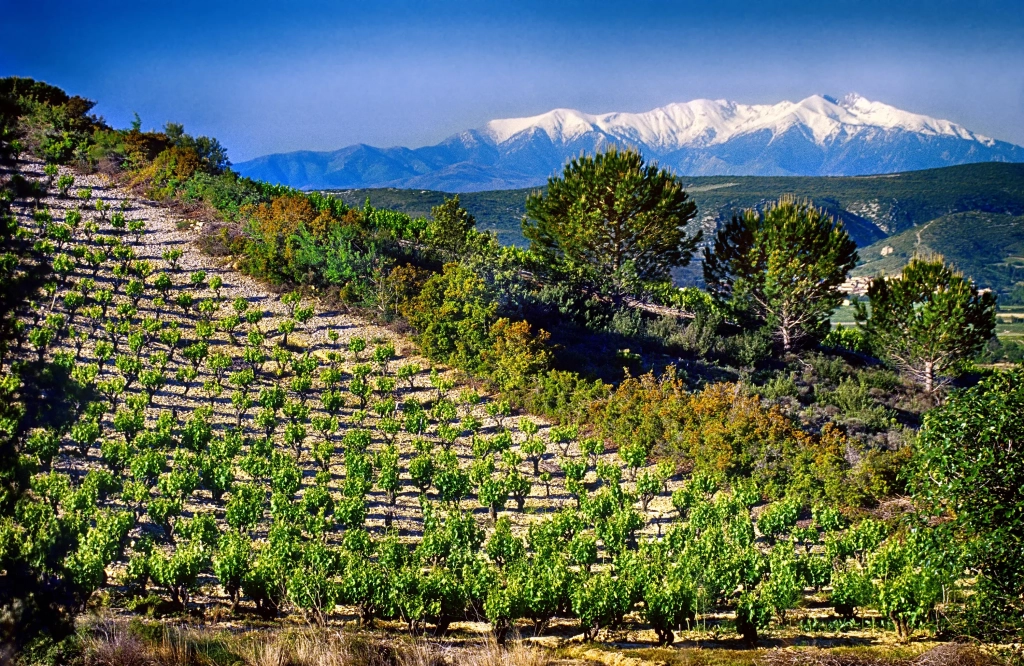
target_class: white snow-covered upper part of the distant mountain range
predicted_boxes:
[480,92,991,150]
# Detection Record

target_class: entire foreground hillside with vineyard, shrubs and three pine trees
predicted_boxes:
[0,79,1024,666]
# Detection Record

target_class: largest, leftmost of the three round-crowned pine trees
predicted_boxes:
[522,147,700,297]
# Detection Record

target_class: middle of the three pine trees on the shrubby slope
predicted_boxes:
[703,200,857,352]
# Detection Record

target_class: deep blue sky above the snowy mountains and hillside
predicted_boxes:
[0,0,1024,162]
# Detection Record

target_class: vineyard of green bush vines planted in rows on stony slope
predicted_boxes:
[5,163,991,663]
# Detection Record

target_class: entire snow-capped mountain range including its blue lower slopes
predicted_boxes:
[236,94,1024,192]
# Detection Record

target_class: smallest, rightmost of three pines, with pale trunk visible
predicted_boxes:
[856,257,995,392]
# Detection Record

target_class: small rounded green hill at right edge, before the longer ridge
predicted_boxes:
[853,211,1024,293]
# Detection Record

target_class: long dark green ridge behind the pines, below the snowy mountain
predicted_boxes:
[332,163,1024,288]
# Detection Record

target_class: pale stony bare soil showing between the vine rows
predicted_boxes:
[12,157,974,663]
